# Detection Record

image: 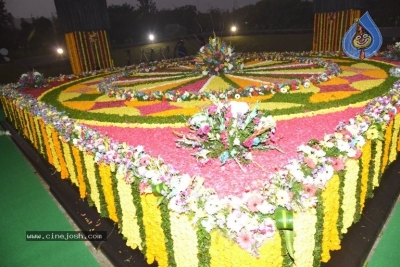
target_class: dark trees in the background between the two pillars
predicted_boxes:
[108,0,313,44]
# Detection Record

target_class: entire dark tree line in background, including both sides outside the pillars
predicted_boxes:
[0,0,400,54]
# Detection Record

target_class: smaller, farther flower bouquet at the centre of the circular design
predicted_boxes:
[195,36,243,75]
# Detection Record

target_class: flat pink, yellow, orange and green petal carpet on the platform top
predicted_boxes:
[35,58,396,196]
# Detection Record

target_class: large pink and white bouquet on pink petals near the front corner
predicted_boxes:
[176,101,280,170]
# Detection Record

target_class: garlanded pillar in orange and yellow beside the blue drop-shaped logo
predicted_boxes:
[312,0,366,52]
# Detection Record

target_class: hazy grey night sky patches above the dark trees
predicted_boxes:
[4,0,259,18]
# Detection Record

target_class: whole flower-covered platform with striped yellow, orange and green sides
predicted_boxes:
[0,38,400,267]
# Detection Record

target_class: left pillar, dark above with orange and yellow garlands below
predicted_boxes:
[54,0,114,74]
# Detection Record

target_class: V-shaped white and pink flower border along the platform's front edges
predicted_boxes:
[0,59,400,256]
